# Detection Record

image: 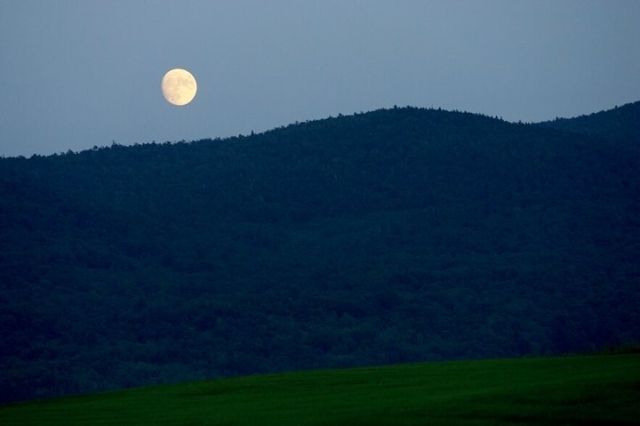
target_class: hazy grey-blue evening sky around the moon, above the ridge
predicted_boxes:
[0,0,640,157]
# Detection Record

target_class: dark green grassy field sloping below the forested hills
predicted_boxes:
[0,354,640,426]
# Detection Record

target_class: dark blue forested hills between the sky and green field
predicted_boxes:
[0,103,640,401]
